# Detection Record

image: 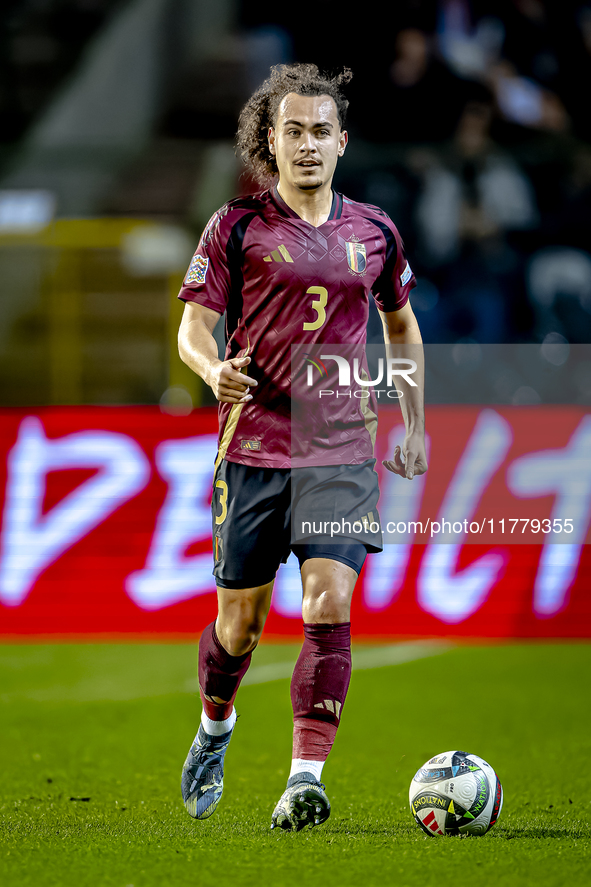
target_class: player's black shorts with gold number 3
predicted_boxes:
[211,460,382,588]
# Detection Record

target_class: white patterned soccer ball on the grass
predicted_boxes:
[408,751,503,835]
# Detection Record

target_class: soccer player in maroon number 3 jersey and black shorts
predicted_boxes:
[179,64,427,831]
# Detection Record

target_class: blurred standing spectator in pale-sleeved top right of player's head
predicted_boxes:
[409,89,538,342]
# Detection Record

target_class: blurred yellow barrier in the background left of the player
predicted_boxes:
[0,218,204,408]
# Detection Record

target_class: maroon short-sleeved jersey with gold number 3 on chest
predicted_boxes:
[179,188,416,468]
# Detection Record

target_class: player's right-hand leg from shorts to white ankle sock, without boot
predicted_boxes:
[291,459,382,796]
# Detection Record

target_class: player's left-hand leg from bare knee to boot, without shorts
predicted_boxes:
[181,582,273,819]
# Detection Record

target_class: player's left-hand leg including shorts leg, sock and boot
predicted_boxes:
[181,462,289,819]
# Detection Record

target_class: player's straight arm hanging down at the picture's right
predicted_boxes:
[380,301,427,480]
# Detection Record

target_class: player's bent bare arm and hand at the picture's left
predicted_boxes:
[179,302,257,403]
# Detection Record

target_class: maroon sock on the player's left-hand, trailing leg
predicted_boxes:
[199,622,252,721]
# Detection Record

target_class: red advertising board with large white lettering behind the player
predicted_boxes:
[0,406,591,639]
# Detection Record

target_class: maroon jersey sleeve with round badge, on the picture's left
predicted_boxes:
[178,207,231,314]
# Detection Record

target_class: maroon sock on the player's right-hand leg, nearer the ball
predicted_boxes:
[291,622,351,761]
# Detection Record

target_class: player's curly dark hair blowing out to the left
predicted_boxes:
[236,63,353,185]
